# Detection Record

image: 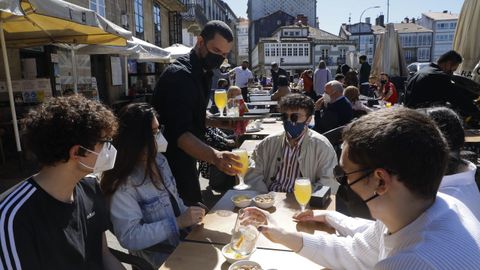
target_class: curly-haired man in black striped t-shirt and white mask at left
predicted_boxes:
[0,95,125,269]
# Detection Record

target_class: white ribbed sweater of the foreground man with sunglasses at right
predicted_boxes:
[299,194,480,270]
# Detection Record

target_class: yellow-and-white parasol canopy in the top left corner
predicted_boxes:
[0,0,131,47]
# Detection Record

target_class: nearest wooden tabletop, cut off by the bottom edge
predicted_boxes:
[160,242,324,270]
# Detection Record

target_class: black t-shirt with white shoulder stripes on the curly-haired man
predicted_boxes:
[0,177,109,269]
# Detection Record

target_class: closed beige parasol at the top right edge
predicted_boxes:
[453,0,480,83]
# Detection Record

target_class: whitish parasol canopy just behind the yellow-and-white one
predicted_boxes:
[77,37,170,62]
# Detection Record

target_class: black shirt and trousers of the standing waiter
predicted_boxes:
[152,50,213,205]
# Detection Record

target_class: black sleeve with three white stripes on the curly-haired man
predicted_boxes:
[0,181,38,269]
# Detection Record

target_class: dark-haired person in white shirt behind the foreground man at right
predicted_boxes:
[426,107,480,220]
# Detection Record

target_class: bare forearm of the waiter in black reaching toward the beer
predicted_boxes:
[177,132,216,164]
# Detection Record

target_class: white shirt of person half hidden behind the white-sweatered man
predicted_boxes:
[438,161,480,219]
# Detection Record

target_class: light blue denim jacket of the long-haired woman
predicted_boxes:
[110,153,187,267]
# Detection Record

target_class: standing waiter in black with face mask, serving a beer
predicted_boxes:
[152,21,241,205]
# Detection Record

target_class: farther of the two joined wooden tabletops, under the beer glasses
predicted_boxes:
[186,190,335,251]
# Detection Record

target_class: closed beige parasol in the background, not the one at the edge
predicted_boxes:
[372,23,408,77]
